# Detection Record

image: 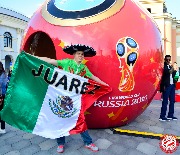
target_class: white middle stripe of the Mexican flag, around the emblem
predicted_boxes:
[32,68,88,139]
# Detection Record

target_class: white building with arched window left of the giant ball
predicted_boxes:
[0,7,29,71]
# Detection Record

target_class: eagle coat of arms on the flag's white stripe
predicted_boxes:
[49,96,77,118]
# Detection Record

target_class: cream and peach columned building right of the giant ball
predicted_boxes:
[139,0,180,66]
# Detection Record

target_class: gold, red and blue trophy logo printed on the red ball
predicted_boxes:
[116,37,139,92]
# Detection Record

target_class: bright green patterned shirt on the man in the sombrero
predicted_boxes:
[57,59,92,78]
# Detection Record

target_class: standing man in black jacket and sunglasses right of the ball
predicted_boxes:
[159,55,178,121]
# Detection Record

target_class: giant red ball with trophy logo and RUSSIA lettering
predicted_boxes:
[21,0,162,128]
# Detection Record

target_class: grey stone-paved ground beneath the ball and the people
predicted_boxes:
[0,100,180,155]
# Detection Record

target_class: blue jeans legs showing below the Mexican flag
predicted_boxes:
[57,130,92,146]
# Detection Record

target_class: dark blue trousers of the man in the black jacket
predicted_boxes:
[160,84,175,118]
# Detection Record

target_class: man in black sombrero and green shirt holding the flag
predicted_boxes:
[35,44,108,153]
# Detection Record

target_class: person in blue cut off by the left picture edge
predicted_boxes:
[0,62,7,134]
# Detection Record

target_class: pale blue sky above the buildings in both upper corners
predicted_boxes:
[0,0,180,20]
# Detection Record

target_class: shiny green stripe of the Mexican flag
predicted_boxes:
[1,52,54,132]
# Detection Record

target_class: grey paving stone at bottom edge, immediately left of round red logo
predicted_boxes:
[136,143,157,155]
